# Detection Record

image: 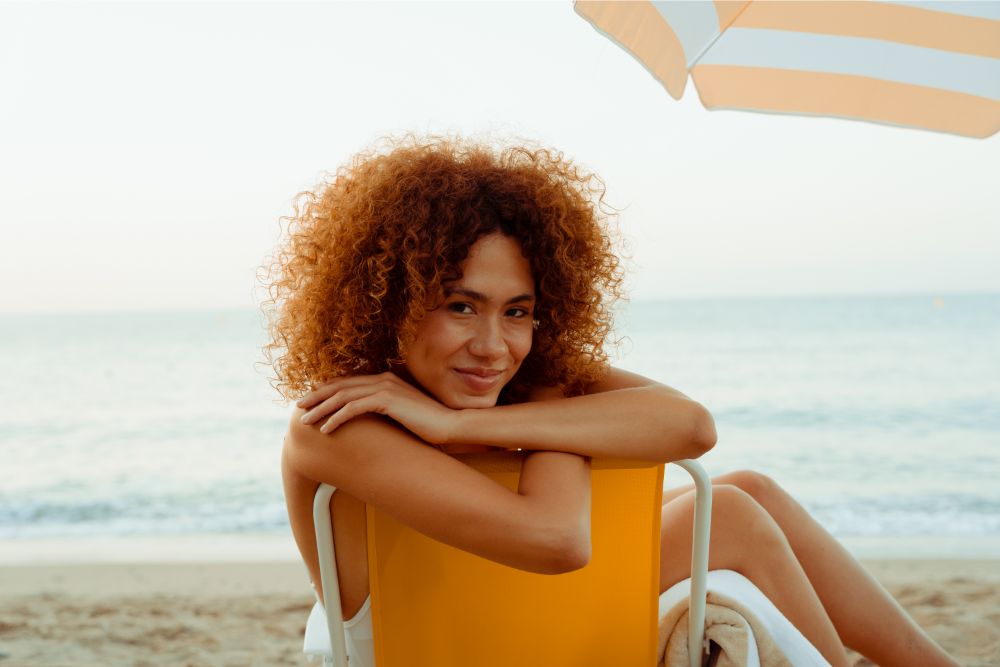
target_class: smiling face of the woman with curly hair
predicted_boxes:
[402,233,535,409]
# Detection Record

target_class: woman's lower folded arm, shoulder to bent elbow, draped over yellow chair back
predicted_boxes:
[283,410,590,574]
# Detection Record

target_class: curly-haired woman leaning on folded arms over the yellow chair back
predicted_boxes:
[268,139,956,666]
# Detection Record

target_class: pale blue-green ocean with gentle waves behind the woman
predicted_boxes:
[0,294,1000,552]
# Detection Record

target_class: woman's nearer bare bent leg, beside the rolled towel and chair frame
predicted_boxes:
[660,485,847,667]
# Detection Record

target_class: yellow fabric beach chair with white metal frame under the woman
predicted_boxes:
[306,452,711,667]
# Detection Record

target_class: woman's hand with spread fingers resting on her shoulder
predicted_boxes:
[297,372,458,445]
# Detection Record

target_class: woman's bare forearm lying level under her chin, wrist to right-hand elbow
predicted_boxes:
[450,385,716,461]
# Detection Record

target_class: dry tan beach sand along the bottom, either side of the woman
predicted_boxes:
[0,559,1000,667]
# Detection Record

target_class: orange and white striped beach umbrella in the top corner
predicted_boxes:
[575,0,1000,137]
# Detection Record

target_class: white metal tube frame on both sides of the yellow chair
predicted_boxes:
[313,459,712,667]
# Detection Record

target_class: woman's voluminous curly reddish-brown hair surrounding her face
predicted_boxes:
[263,137,622,402]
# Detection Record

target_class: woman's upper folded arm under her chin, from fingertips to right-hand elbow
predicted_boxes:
[299,368,716,462]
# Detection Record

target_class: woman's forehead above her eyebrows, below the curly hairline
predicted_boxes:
[445,234,535,297]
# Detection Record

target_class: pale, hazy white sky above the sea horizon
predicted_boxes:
[0,2,1000,313]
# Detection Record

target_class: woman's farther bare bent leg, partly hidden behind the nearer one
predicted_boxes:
[664,471,958,667]
